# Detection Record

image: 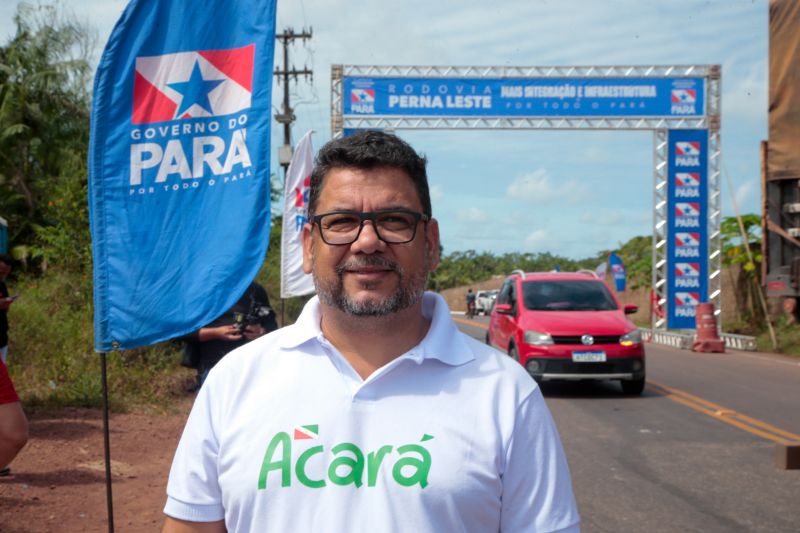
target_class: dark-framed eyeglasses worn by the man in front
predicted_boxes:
[311,209,430,244]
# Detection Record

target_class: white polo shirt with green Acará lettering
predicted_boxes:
[164,293,579,533]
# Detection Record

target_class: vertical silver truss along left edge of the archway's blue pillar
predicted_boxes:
[650,129,670,330]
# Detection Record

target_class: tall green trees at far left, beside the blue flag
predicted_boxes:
[0,3,95,264]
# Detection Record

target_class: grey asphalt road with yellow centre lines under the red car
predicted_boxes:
[455,317,800,532]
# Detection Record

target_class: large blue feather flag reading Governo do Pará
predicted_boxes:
[89,0,275,351]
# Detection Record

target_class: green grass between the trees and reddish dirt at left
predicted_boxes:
[9,273,193,411]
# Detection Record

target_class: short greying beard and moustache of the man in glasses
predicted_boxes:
[314,251,430,317]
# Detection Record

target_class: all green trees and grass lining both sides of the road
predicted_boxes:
[0,4,788,411]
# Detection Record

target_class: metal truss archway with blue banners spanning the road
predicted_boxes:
[331,65,722,331]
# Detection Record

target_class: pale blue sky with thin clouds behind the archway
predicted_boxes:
[0,0,768,259]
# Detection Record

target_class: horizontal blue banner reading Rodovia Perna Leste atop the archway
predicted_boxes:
[343,76,706,117]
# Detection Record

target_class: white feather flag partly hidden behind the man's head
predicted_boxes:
[281,131,314,298]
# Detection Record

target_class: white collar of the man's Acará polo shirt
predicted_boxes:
[280,292,475,366]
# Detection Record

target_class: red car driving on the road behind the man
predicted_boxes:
[486,270,645,395]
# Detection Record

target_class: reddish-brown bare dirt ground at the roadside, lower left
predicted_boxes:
[0,399,191,533]
